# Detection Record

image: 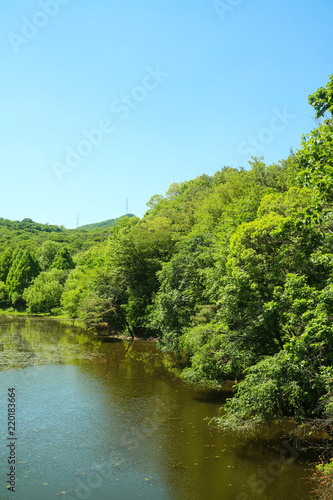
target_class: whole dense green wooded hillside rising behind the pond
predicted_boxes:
[0,76,333,458]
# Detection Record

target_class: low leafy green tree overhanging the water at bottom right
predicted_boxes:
[220,274,333,430]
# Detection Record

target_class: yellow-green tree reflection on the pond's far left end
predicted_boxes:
[0,316,100,369]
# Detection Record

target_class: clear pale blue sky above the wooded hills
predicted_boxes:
[0,0,333,228]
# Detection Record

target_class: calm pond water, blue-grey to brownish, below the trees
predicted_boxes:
[0,317,310,500]
